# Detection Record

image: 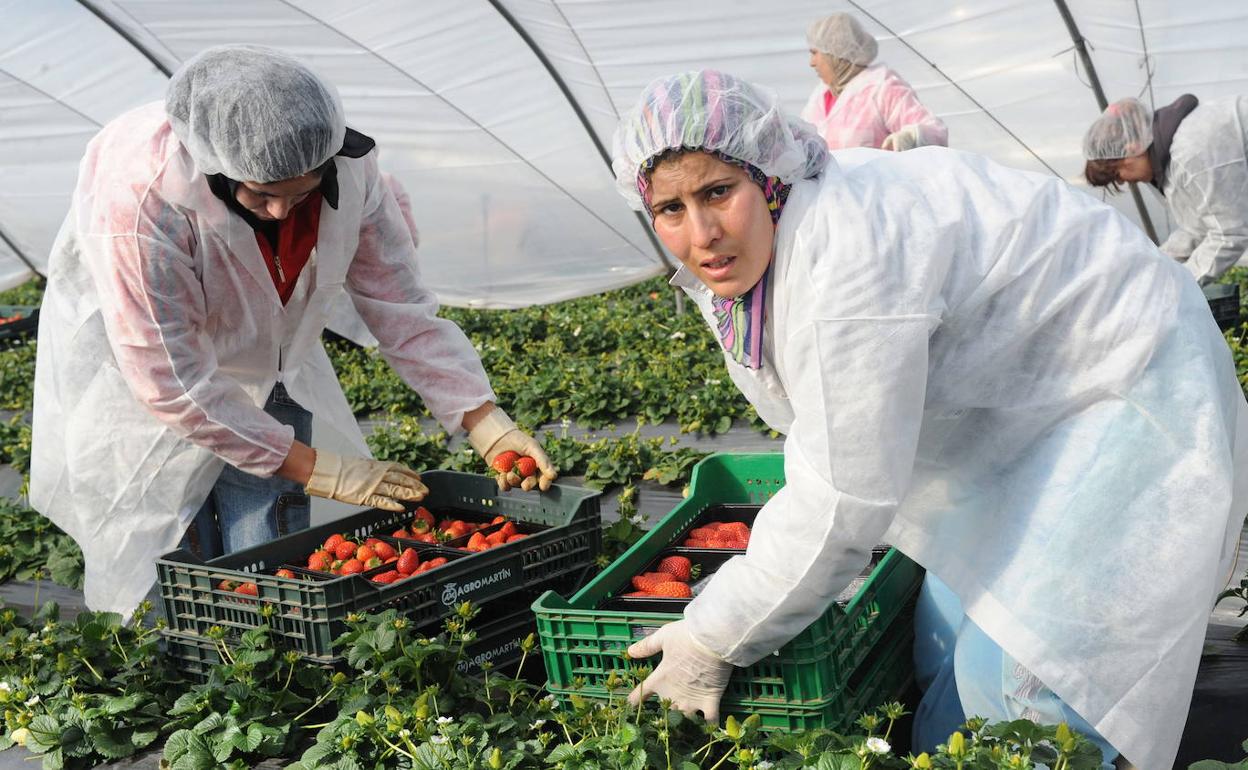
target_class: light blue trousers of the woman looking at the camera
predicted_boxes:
[912,573,1118,769]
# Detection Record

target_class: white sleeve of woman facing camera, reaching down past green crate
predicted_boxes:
[685,314,937,665]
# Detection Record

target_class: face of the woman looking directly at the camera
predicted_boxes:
[649,152,775,298]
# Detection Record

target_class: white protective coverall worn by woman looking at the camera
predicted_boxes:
[674,149,1248,770]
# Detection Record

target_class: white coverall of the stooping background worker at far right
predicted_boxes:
[1162,96,1248,283]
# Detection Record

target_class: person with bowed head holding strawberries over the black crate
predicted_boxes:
[30,46,554,613]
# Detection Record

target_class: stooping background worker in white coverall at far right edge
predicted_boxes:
[1083,94,1248,283]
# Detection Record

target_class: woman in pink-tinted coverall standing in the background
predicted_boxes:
[801,14,948,151]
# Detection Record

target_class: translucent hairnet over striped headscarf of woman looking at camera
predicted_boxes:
[612,70,827,211]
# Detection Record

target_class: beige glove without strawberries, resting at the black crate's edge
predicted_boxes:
[303,449,429,510]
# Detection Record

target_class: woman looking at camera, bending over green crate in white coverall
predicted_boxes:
[614,71,1248,770]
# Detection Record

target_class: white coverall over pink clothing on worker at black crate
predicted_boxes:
[30,104,494,613]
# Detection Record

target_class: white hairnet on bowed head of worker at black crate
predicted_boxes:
[165,45,347,182]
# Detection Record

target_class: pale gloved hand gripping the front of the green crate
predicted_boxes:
[628,620,733,724]
